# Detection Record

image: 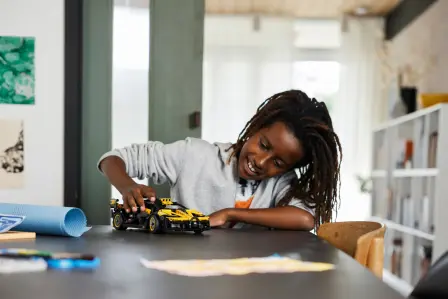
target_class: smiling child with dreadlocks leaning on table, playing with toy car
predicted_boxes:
[98,90,341,230]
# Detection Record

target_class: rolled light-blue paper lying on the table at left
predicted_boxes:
[0,203,90,237]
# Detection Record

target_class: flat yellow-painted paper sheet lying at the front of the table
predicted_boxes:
[141,257,334,277]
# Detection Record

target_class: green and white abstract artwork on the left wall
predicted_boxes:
[0,36,35,105]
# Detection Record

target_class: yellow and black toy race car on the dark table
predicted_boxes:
[110,198,210,234]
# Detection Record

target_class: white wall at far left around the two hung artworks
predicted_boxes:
[0,0,64,205]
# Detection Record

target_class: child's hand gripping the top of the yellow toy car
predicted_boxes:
[121,184,156,213]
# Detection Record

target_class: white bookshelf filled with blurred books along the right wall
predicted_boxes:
[371,104,448,296]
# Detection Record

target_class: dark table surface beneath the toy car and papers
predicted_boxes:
[0,226,403,299]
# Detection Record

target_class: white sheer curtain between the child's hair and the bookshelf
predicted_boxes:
[333,18,384,221]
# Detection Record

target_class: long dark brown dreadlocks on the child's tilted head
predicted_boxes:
[228,90,342,229]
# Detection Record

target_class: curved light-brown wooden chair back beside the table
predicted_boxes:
[317,221,386,278]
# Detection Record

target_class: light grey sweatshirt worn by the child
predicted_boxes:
[98,138,314,227]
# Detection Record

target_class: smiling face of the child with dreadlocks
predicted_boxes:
[238,122,305,180]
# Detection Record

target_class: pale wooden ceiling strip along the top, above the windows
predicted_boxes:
[205,0,401,18]
